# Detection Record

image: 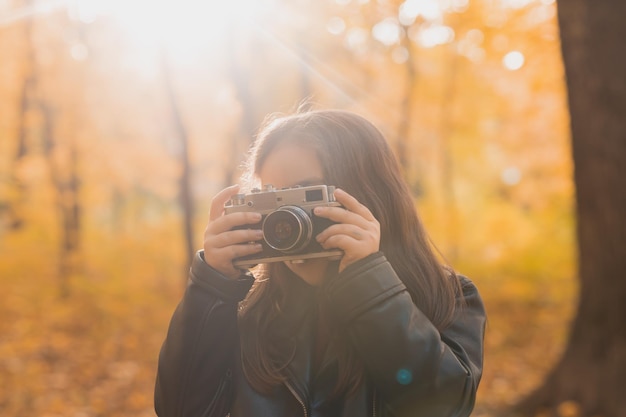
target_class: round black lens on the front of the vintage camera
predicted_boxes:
[262,206,313,253]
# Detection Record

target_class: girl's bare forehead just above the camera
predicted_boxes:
[259,144,324,188]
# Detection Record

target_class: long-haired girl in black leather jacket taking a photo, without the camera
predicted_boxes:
[155,111,485,417]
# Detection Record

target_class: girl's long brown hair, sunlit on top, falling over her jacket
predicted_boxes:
[239,110,459,392]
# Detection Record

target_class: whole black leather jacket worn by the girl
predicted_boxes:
[155,252,485,417]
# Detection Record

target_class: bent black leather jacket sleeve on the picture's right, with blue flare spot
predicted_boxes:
[324,253,486,417]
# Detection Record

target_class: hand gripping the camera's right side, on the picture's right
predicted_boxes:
[315,189,380,272]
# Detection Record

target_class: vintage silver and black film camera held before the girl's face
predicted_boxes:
[224,184,343,268]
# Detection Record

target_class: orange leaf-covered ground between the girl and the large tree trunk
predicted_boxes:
[472,268,577,417]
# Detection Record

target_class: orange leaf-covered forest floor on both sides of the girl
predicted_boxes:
[0,234,576,417]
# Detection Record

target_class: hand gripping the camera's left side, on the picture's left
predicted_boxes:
[204,185,263,279]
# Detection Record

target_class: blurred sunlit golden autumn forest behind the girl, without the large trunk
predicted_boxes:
[0,0,578,417]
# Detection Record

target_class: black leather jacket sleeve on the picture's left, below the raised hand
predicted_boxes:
[154,251,253,417]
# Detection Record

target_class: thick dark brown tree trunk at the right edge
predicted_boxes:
[519,0,626,417]
